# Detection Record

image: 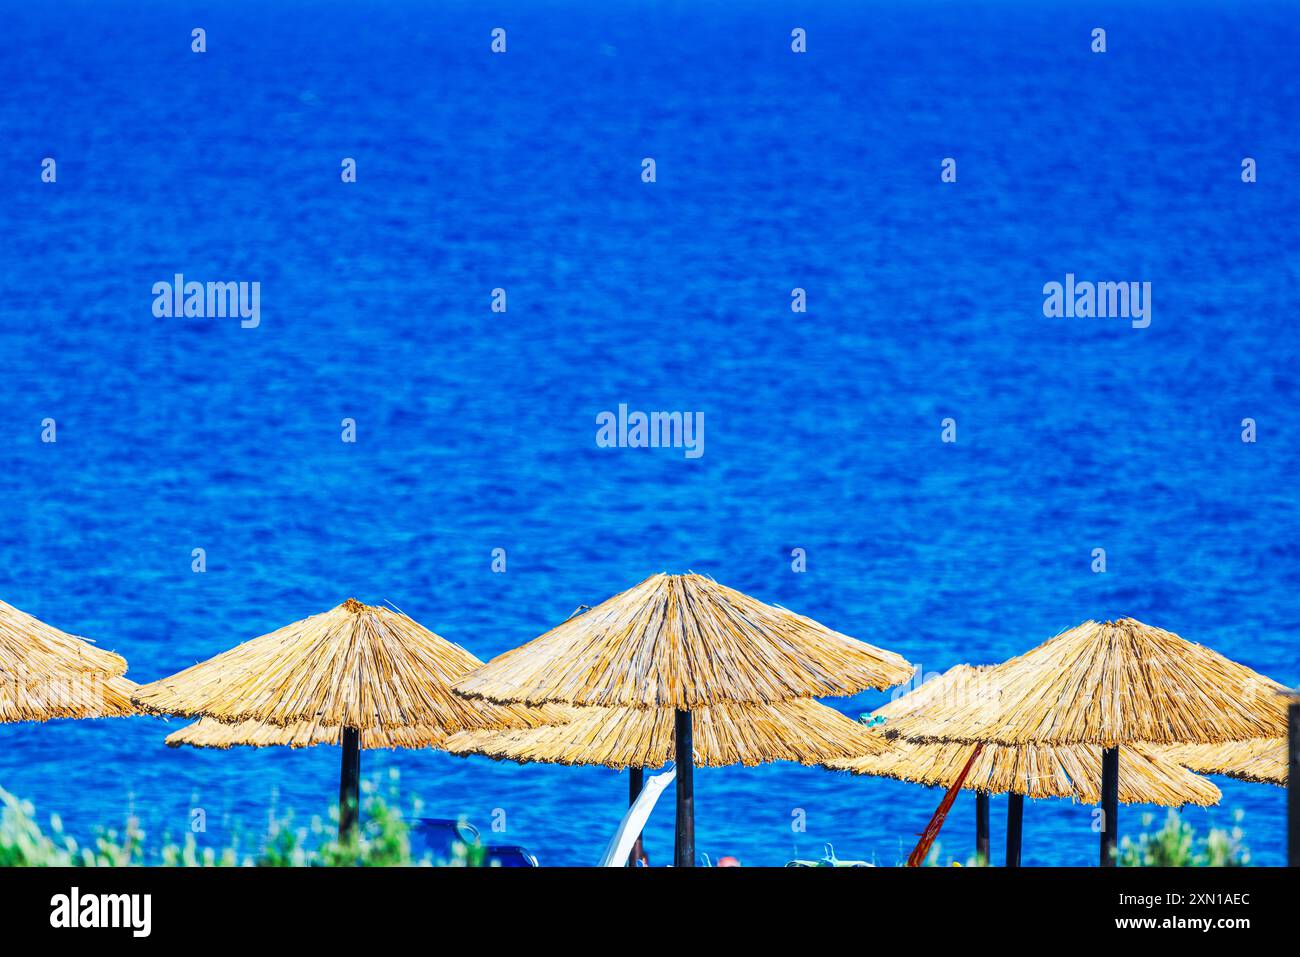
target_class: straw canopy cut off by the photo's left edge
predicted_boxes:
[0,602,135,722]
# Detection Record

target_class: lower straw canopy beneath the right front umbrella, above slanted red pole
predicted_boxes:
[826,740,1222,807]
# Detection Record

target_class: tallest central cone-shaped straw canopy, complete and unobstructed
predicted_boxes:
[456,566,914,710]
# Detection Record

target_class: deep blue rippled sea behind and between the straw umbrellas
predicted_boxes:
[0,0,1300,865]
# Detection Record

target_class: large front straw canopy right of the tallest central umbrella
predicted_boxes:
[893,618,1286,748]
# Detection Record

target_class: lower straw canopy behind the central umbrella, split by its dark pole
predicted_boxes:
[443,698,889,768]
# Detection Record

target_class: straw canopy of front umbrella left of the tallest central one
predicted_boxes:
[133,598,567,732]
